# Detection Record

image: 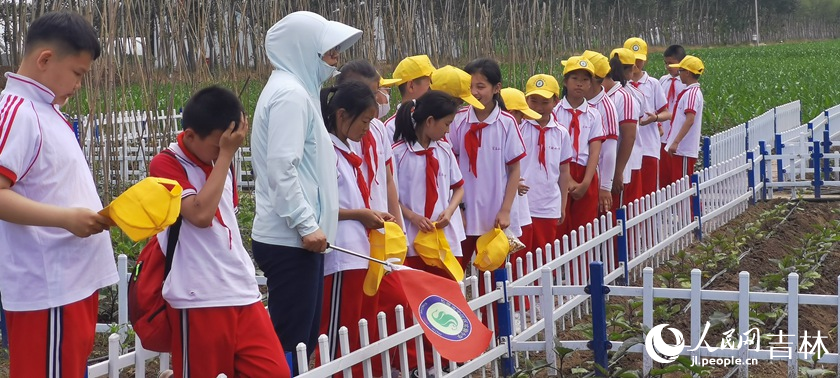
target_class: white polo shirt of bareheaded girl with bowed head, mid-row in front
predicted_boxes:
[394,140,466,256]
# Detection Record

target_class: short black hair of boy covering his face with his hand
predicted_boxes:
[183,85,243,138]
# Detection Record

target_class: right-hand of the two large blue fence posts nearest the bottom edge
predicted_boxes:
[585,261,612,377]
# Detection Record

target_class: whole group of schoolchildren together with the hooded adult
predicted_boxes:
[0,8,704,377]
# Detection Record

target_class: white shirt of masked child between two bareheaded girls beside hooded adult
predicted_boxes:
[347,118,399,216]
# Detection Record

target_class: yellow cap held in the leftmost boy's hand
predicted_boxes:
[99,177,183,241]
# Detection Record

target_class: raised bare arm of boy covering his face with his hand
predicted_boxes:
[181,119,248,228]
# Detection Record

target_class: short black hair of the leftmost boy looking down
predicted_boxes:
[24,11,102,60]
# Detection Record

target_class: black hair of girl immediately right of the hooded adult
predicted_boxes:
[321,80,376,134]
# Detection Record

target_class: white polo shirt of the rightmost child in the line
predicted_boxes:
[668,83,703,158]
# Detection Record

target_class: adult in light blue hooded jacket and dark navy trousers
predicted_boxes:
[251,12,362,370]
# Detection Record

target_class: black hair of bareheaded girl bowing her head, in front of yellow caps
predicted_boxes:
[394,91,459,144]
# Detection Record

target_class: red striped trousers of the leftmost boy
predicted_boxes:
[6,293,99,378]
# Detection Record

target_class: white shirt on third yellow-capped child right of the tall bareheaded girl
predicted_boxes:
[554,97,606,167]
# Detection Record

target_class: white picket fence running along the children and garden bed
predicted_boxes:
[80,102,840,377]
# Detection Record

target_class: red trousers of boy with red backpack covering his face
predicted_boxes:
[167,302,291,377]
